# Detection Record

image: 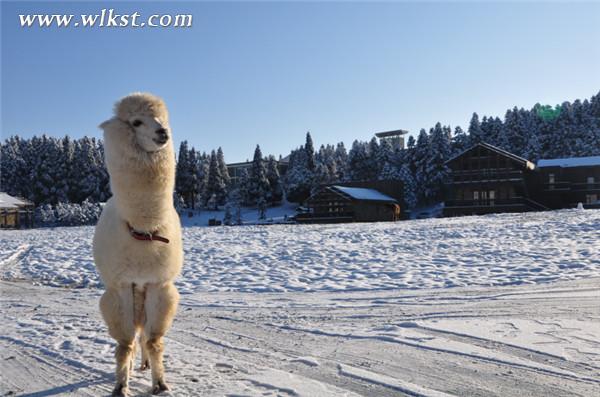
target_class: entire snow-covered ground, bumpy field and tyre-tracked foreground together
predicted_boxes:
[0,210,600,397]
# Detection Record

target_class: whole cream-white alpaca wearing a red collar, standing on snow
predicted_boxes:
[93,93,183,396]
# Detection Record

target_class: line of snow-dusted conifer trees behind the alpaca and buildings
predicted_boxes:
[0,93,600,212]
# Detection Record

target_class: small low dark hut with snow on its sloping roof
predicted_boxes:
[296,185,400,223]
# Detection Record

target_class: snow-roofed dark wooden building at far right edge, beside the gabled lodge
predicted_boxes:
[536,156,600,209]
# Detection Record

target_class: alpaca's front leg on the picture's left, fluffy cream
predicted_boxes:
[100,288,135,396]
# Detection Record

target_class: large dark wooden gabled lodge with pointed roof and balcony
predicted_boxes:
[444,143,545,216]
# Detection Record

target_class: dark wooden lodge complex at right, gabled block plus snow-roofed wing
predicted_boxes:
[444,142,600,216]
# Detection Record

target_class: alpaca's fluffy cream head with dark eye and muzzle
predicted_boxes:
[105,93,171,152]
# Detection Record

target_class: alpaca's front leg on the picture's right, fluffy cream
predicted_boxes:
[144,283,179,394]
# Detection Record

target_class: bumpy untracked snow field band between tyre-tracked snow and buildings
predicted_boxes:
[0,210,600,293]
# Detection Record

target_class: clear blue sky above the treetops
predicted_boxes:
[1,1,600,162]
